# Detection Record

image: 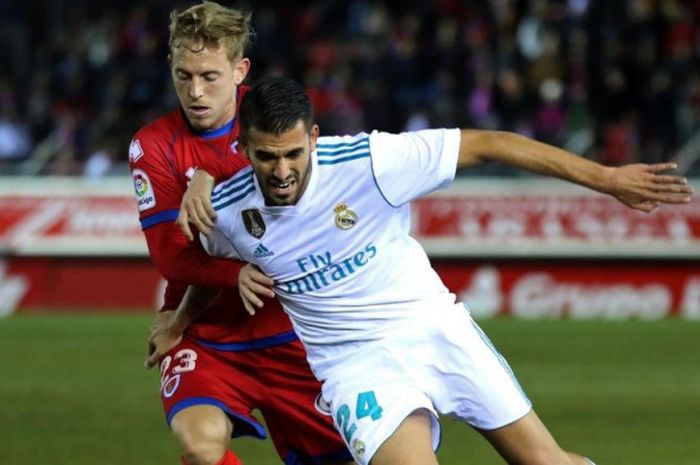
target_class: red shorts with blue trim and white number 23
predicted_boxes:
[160,338,352,465]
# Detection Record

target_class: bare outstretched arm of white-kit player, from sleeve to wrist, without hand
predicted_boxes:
[457,130,610,192]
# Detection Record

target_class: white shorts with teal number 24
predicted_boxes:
[323,303,532,465]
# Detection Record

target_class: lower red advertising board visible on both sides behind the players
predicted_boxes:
[0,254,700,319]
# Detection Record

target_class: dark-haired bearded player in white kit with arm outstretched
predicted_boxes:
[178,78,692,465]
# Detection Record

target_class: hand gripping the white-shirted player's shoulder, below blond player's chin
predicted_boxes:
[175,170,216,241]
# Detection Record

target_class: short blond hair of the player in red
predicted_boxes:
[168,1,252,63]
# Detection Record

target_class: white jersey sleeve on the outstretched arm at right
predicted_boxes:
[369,129,460,206]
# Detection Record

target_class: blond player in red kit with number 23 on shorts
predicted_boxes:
[129,2,351,465]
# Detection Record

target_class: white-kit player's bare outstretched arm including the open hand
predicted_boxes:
[457,129,693,212]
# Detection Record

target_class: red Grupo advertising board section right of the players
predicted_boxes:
[433,260,700,319]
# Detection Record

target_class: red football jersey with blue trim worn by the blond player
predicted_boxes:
[129,87,296,349]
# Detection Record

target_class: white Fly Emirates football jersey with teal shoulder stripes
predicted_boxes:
[203,129,460,379]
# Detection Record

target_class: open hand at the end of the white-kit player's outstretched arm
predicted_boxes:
[607,163,693,212]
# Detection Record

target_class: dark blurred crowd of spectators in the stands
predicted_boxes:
[0,0,700,176]
